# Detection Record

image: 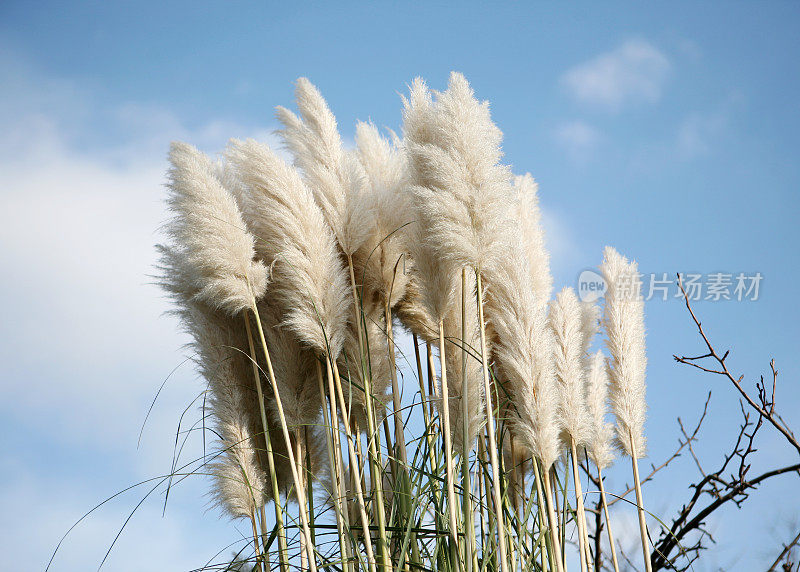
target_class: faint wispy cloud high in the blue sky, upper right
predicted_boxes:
[561,40,671,110]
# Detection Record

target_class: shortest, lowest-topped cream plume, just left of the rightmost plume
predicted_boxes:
[586,350,614,470]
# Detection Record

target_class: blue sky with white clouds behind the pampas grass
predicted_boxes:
[0,1,800,570]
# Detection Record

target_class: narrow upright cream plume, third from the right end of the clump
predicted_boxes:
[549,288,589,446]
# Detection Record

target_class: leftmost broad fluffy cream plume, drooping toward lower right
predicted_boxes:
[166,142,267,314]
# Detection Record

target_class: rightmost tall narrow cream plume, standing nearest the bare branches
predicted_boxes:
[600,246,647,457]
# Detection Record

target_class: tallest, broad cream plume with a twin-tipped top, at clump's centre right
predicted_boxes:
[403,72,513,269]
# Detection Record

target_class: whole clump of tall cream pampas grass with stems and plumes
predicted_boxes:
[155,74,649,572]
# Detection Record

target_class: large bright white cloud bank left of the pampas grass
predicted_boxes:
[0,60,278,452]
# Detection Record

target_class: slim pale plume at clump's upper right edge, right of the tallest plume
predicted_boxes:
[514,173,553,304]
